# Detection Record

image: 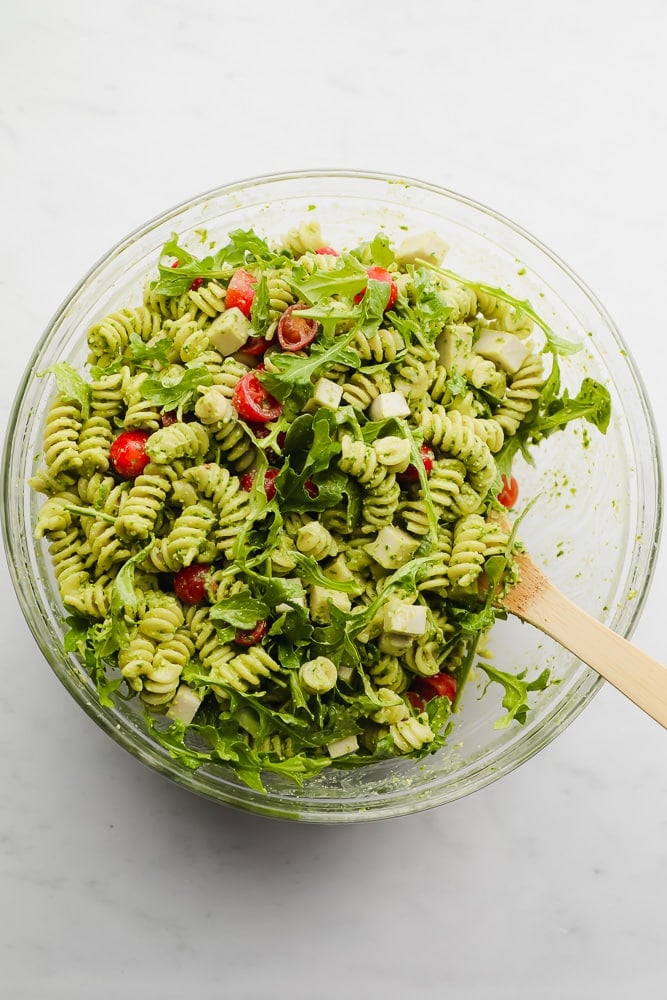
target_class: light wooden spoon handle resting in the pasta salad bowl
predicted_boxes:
[499,552,667,729]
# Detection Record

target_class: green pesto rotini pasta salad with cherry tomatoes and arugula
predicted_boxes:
[30,221,610,789]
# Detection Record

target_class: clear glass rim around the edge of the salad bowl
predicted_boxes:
[1,168,663,824]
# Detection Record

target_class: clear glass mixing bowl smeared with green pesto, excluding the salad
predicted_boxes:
[3,171,661,823]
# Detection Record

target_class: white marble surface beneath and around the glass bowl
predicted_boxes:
[0,0,667,1000]
